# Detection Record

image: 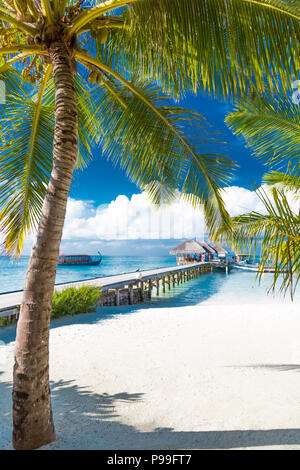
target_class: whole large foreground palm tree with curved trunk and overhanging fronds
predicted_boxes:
[0,0,300,449]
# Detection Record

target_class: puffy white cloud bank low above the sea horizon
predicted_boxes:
[63,186,272,240]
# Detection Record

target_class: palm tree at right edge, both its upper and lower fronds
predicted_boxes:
[218,89,300,300]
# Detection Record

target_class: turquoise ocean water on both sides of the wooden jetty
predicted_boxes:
[0,256,300,304]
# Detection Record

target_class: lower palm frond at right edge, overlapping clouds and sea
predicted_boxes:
[217,188,300,299]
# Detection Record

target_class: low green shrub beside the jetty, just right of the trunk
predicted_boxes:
[51,286,101,318]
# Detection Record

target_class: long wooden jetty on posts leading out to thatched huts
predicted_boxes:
[0,262,213,323]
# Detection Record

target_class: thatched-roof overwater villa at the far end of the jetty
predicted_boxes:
[170,240,228,264]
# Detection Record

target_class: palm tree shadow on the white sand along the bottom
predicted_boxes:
[0,372,300,450]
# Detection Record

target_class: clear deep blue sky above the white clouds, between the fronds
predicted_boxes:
[71,95,263,205]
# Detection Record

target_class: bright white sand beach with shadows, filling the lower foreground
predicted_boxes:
[0,303,300,449]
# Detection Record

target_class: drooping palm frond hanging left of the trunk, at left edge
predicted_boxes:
[0,87,54,255]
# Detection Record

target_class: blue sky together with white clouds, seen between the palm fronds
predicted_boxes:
[24,92,264,256]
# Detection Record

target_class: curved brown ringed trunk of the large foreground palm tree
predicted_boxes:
[13,42,78,449]
